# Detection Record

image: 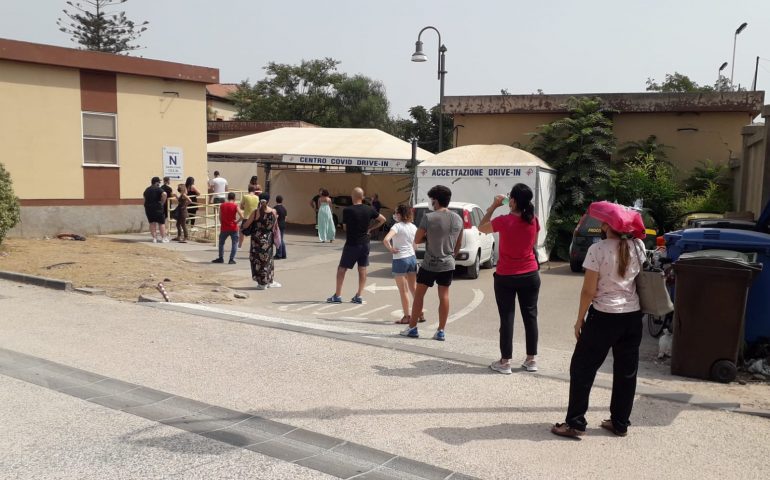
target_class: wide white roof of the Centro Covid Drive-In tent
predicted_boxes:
[208,127,434,160]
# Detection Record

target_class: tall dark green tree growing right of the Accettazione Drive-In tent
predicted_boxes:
[530,97,615,260]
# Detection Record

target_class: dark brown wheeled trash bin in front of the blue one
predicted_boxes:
[671,250,762,383]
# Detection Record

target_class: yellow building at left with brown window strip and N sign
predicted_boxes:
[0,39,219,236]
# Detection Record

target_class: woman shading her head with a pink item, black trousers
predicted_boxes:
[551,202,645,438]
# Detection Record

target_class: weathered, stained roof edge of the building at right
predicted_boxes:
[444,91,765,116]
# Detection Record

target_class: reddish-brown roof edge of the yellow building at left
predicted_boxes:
[0,38,219,84]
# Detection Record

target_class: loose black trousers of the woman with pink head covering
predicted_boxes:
[566,307,642,432]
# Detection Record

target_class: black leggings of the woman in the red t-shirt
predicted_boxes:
[495,270,540,359]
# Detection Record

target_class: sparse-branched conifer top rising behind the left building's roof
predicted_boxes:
[56,0,149,53]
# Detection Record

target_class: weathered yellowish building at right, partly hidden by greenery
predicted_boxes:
[444,92,765,175]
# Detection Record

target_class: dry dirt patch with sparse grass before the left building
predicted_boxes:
[0,237,233,303]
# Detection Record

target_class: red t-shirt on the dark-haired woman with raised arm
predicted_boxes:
[492,213,540,275]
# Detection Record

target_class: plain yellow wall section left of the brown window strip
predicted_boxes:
[0,60,83,200]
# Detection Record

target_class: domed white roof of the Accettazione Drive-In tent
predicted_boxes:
[420,145,552,170]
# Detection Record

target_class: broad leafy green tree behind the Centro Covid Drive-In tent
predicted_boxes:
[231,58,390,129]
